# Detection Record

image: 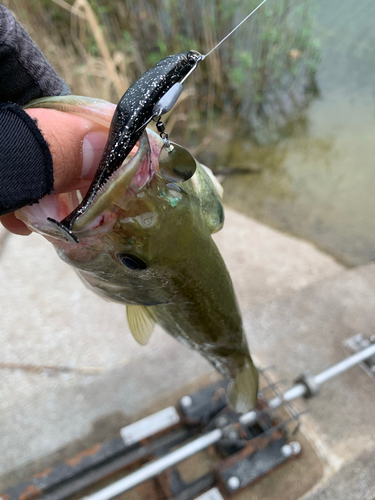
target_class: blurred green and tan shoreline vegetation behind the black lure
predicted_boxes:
[6,0,319,142]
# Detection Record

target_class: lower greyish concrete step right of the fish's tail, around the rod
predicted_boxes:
[244,264,375,500]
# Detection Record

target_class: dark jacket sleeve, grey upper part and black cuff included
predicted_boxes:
[0,5,70,215]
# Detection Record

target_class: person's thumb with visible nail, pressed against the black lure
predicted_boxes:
[26,109,108,193]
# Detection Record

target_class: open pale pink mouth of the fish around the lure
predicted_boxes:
[16,98,163,243]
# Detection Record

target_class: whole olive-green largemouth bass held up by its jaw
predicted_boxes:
[17,92,258,412]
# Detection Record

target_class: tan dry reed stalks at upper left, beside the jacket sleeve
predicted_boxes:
[7,0,132,102]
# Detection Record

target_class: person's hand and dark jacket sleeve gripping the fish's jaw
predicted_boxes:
[0,5,108,234]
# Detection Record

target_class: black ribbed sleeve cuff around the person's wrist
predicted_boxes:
[0,103,53,215]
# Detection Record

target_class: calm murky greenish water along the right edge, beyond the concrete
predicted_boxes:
[224,0,375,266]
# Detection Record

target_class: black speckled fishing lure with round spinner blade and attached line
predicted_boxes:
[48,0,266,243]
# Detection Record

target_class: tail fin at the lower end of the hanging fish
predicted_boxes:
[228,358,258,413]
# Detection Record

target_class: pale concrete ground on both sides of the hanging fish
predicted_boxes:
[0,206,375,500]
